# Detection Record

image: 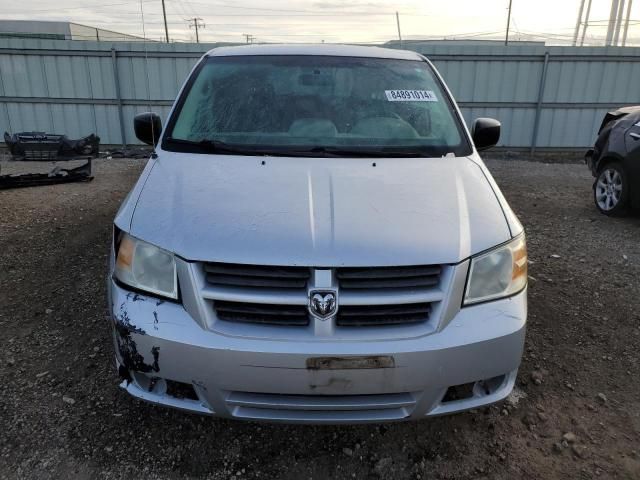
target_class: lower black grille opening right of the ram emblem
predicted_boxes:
[336,303,431,327]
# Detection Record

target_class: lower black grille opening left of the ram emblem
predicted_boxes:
[213,300,309,326]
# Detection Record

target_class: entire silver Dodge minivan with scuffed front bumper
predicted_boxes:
[108,45,527,423]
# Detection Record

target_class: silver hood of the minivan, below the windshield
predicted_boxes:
[130,152,511,267]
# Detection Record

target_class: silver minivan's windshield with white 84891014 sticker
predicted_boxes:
[163,55,471,156]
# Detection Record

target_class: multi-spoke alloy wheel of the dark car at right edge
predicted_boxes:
[593,162,629,216]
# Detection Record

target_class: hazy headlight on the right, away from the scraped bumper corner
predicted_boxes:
[464,235,527,305]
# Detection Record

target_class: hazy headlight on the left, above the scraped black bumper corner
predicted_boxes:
[114,233,178,299]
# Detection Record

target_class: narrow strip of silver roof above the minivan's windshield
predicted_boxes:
[207,44,422,60]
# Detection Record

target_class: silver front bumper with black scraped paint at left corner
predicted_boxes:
[109,281,527,423]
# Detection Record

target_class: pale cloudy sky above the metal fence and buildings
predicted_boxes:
[2,0,640,45]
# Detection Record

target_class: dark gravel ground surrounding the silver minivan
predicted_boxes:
[0,156,640,480]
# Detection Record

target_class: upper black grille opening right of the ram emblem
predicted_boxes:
[336,265,442,290]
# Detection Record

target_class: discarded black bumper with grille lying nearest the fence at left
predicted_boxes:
[4,132,100,162]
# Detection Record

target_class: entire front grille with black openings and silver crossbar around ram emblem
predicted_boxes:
[202,263,445,335]
